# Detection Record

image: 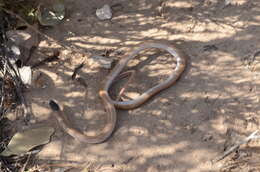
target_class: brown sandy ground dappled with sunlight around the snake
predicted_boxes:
[12,0,260,172]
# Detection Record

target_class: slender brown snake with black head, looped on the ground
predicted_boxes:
[49,42,188,144]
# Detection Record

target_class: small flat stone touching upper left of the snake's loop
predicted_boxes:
[89,55,113,69]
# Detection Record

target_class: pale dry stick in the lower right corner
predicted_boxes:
[212,130,260,163]
